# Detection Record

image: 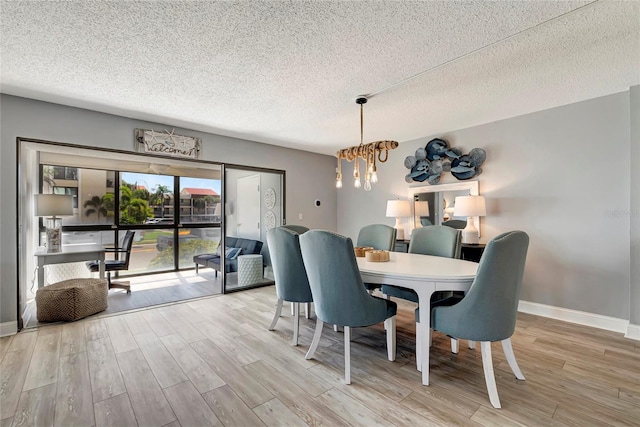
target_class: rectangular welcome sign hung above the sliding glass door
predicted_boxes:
[135,129,201,159]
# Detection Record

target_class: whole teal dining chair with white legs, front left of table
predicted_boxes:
[300,230,397,384]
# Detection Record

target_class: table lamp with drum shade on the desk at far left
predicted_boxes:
[34,194,73,252]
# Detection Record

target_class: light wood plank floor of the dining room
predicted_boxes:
[0,286,640,427]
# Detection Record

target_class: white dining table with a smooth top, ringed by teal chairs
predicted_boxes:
[356,252,478,385]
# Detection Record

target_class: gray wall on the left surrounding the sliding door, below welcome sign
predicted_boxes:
[0,95,337,323]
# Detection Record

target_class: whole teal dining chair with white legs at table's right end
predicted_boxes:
[428,231,529,408]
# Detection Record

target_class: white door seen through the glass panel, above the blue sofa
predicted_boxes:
[236,175,260,240]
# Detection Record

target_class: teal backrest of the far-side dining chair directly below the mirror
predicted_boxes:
[409,225,461,258]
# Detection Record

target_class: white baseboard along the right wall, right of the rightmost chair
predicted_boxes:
[518,300,640,339]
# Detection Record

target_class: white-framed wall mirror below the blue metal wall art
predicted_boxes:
[407,181,480,235]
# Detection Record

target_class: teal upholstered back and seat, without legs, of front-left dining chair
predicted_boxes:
[300,230,388,327]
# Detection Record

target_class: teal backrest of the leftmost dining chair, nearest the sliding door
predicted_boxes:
[267,227,313,302]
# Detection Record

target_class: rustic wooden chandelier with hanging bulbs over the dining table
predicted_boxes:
[336,97,398,191]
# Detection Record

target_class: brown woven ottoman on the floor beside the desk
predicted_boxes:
[36,279,109,322]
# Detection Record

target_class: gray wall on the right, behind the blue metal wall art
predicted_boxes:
[338,88,640,323]
